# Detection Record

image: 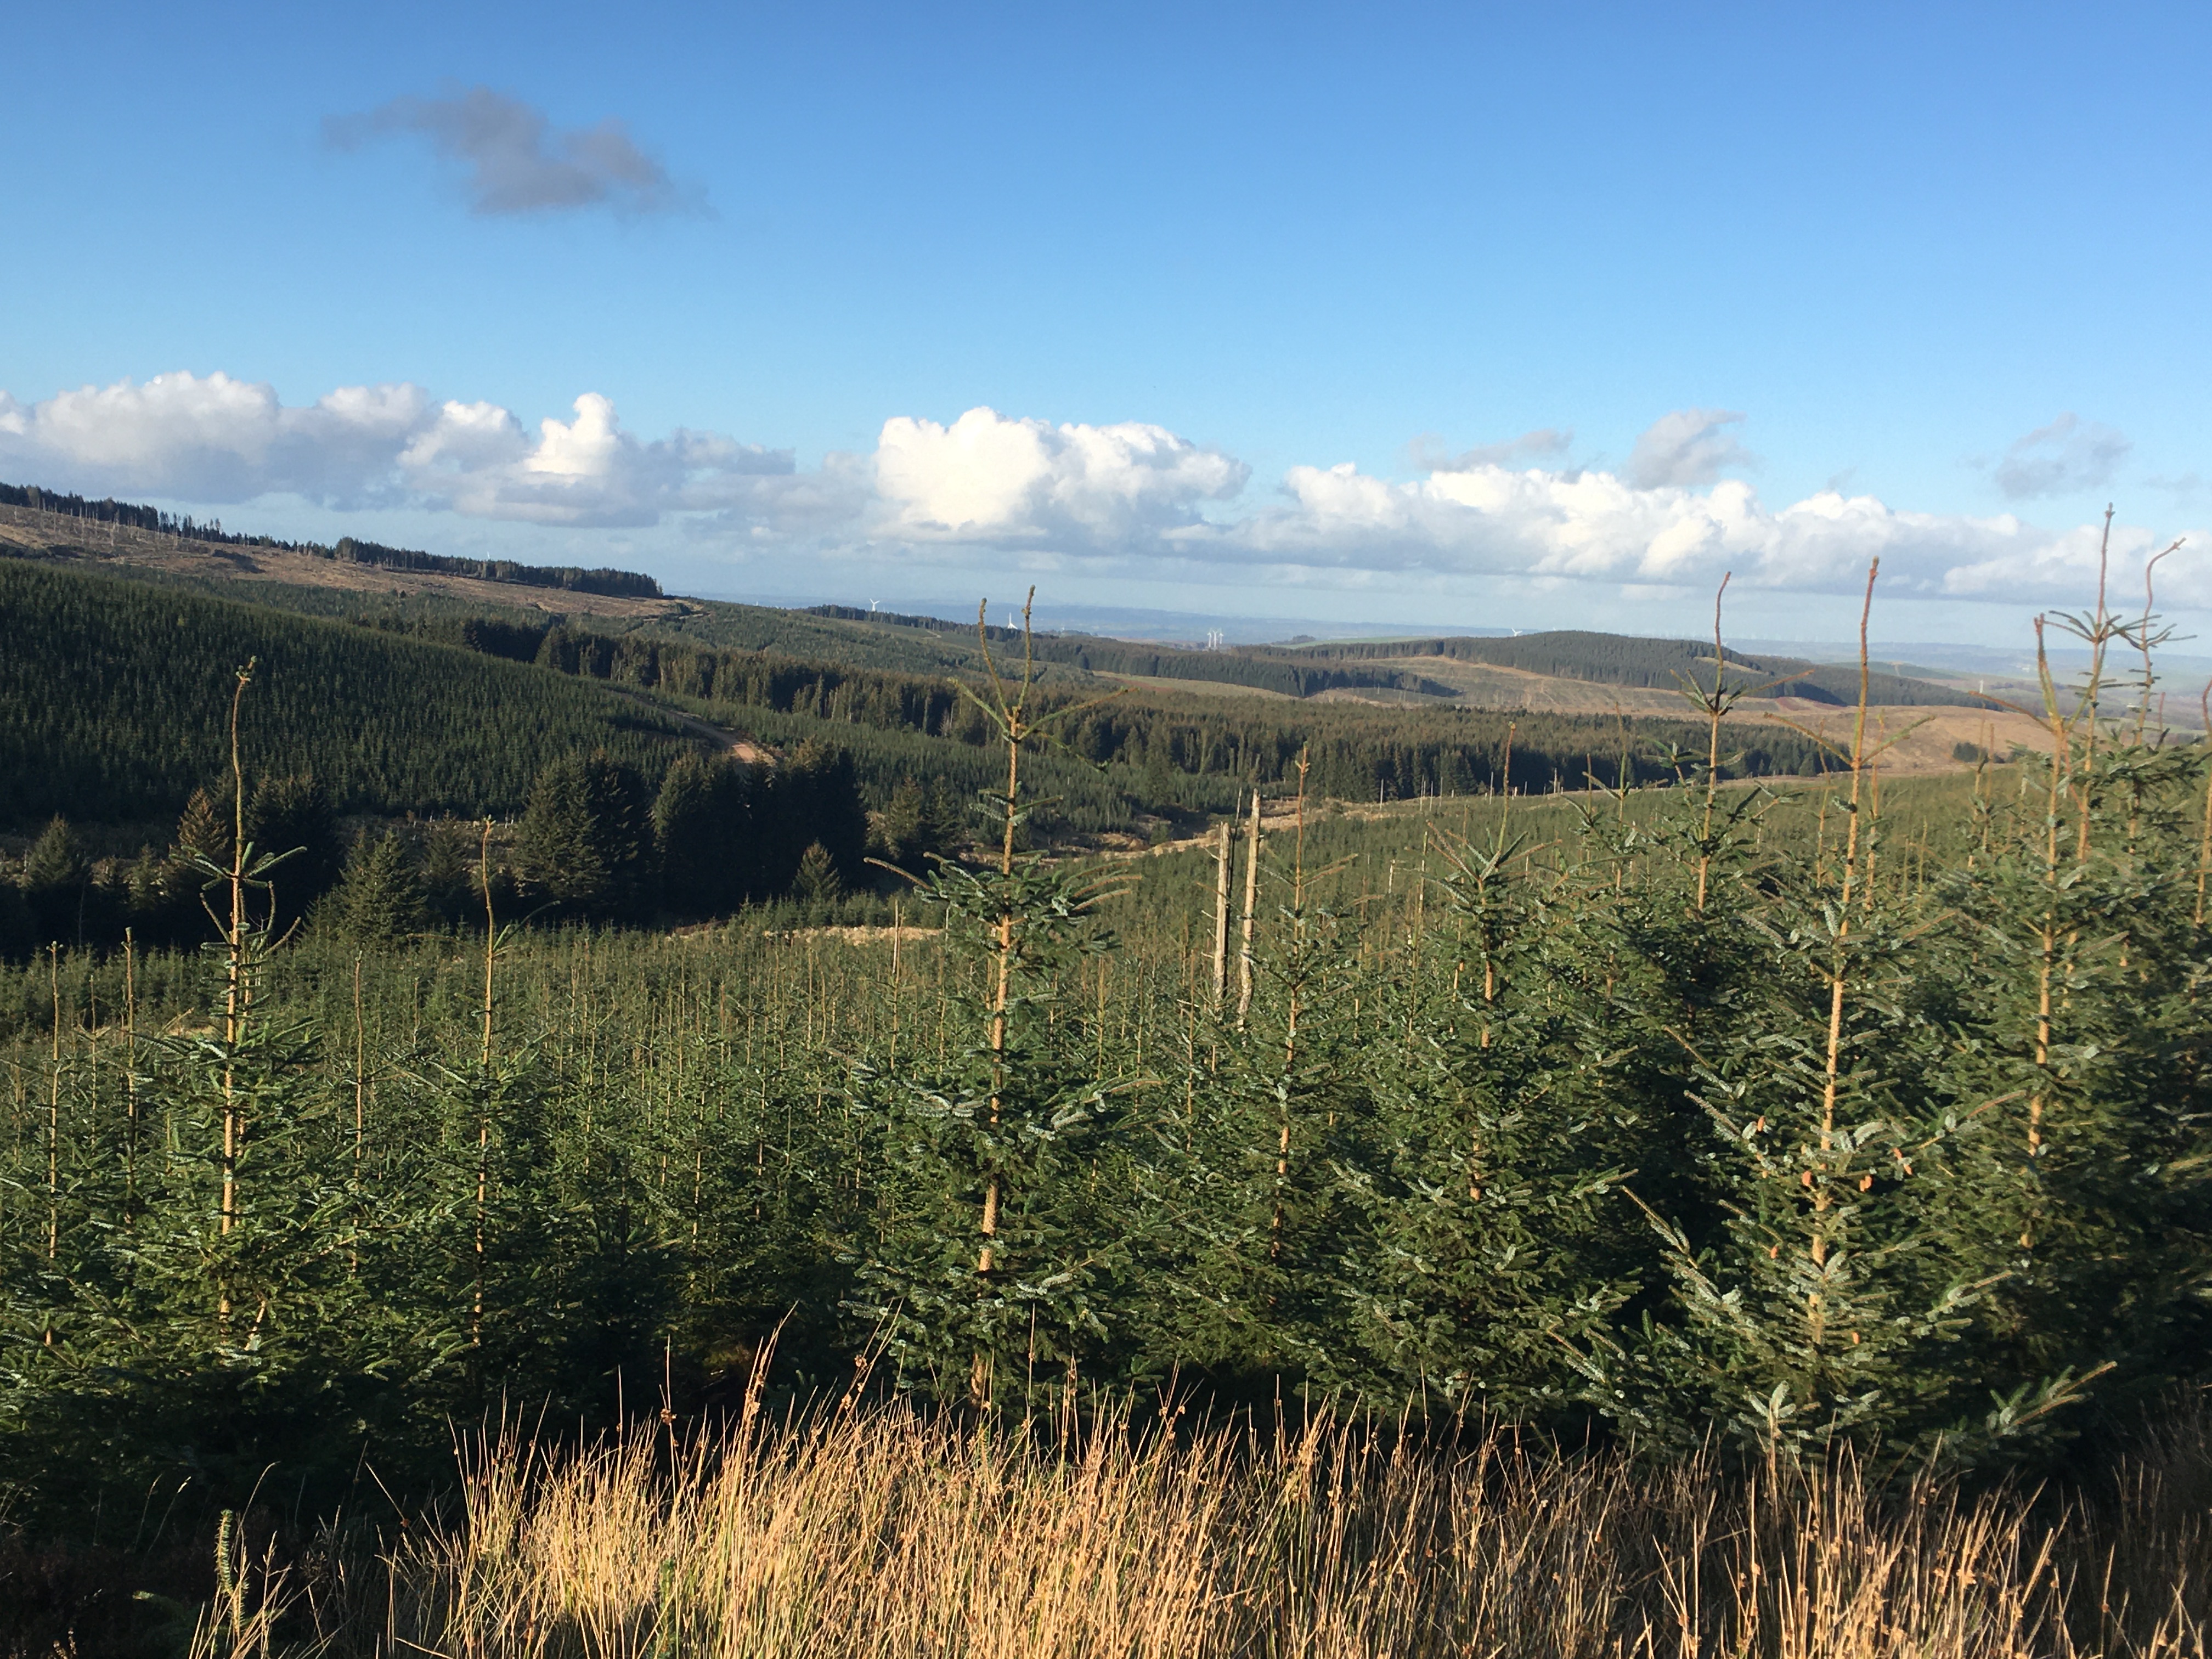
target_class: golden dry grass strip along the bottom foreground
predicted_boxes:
[381,1404,2212,1659]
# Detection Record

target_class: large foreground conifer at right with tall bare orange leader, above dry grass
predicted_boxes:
[1593,566,2097,1458]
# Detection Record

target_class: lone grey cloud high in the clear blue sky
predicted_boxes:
[323,86,701,217]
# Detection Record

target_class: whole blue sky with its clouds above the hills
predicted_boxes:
[0,2,2212,641]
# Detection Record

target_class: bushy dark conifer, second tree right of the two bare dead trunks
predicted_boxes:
[1342,778,1652,1420]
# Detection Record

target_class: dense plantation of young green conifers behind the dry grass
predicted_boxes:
[0,579,2212,1539]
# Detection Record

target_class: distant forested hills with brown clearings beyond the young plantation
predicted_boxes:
[0,484,2002,834]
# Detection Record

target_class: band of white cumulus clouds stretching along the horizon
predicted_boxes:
[0,374,2212,608]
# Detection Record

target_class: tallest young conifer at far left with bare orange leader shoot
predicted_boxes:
[15,664,436,1502]
